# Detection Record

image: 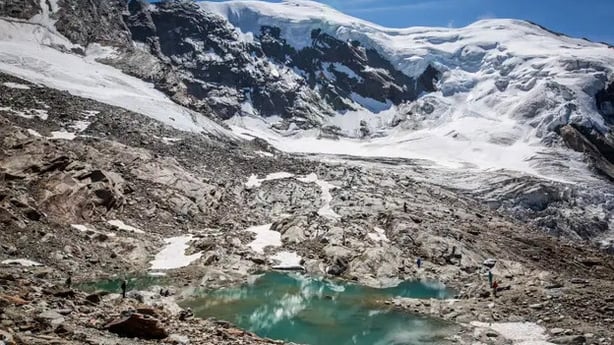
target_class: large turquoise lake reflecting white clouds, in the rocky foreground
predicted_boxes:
[183,272,453,345]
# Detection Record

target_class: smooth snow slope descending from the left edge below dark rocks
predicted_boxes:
[0,15,235,137]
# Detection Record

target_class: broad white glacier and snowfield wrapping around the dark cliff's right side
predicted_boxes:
[201,1,614,176]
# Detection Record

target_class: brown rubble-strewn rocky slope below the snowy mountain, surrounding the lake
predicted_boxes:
[0,75,614,344]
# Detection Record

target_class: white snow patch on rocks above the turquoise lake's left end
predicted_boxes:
[150,235,203,270]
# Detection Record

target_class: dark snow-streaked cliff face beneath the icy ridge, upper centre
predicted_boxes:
[121,1,439,126]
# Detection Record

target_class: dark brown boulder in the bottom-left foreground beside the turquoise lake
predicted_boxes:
[105,313,168,339]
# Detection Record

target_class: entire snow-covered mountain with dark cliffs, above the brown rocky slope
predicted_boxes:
[0,0,614,242]
